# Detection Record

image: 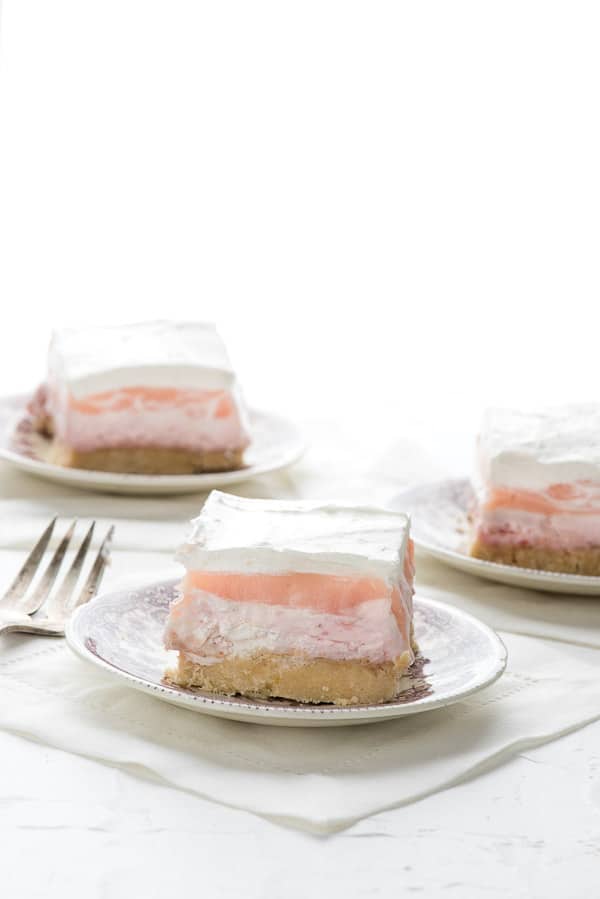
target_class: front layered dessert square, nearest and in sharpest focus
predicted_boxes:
[165,491,414,705]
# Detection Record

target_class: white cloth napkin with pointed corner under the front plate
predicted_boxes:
[0,635,600,833]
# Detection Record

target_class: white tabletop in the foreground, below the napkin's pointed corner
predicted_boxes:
[0,724,600,899]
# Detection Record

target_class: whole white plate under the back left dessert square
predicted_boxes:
[0,396,305,494]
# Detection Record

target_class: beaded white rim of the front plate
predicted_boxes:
[65,577,508,726]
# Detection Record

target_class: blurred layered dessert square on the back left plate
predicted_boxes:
[34,321,249,474]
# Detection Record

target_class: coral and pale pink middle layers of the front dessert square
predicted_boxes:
[165,562,412,664]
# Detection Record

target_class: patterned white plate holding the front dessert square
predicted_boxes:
[66,579,506,727]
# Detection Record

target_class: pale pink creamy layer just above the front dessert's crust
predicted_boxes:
[165,590,410,665]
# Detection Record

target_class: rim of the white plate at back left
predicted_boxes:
[0,393,308,492]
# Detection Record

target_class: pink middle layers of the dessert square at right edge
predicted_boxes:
[476,481,600,549]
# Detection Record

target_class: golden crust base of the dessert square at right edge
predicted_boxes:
[471,540,600,575]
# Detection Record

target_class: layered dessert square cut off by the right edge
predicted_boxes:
[471,405,600,575]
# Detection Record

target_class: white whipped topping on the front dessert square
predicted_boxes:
[177,490,409,582]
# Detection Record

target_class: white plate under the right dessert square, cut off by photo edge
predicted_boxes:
[390,479,600,596]
